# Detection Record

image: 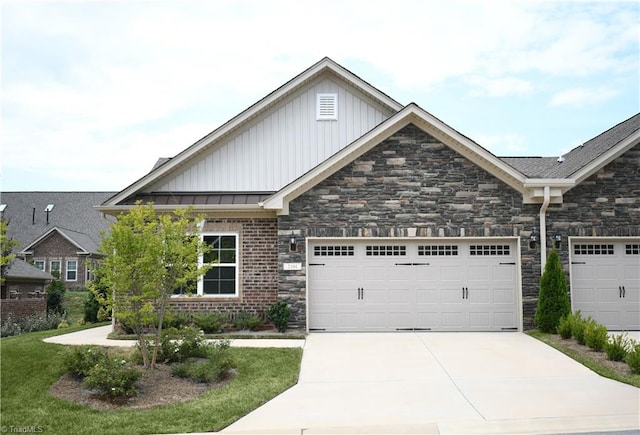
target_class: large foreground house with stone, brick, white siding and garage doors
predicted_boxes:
[99,58,640,331]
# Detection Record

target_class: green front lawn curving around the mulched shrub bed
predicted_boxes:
[0,326,302,434]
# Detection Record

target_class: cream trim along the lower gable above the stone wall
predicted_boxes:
[263,103,526,215]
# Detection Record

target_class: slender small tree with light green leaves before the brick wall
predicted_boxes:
[92,202,207,368]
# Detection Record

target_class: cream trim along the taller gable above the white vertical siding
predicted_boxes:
[104,57,403,206]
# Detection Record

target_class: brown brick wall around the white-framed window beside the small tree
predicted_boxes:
[171,218,278,316]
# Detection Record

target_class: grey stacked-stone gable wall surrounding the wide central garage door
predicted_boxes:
[278,125,540,328]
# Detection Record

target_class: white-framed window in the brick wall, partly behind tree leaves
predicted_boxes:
[198,234,238,296]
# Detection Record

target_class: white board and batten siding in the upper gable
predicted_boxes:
[150,76,392,192]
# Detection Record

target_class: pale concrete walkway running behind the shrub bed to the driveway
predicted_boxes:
[44,325,305,347]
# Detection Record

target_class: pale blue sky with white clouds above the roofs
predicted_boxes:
[0,0,640,191]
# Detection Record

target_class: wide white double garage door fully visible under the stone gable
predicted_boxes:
[307,239,519,331]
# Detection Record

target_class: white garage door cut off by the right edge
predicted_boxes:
[571,239,640,330]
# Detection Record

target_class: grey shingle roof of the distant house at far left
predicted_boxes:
[0,192,114,253]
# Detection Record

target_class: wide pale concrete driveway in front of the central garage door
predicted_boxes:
[223,333,640,435]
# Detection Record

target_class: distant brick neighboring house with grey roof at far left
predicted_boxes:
[0,192,115,289]
